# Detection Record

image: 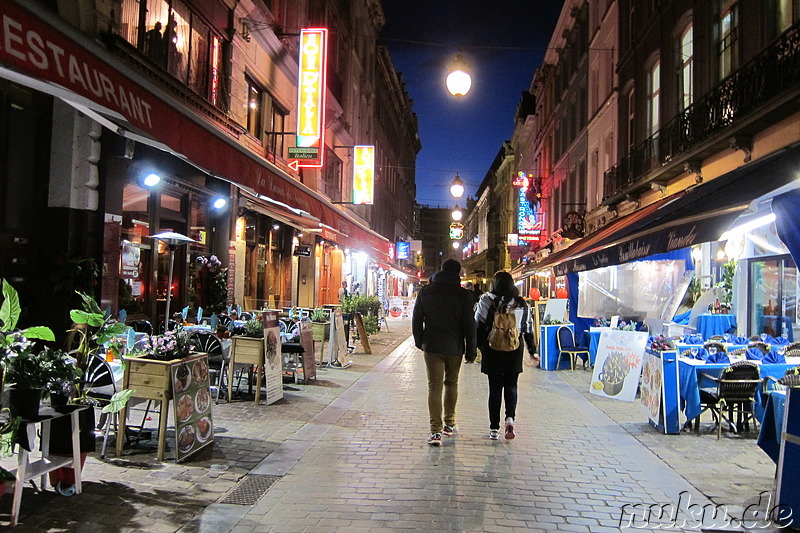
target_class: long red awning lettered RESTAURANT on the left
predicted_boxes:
[0,1,389,259]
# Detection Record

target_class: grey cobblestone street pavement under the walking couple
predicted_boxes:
[2,322,774,533]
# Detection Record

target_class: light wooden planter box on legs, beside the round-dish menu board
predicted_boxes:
[117,356,180,461]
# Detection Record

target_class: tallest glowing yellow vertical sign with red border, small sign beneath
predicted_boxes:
[290,28,328,170]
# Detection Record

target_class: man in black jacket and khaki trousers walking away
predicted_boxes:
[411,259,476,446]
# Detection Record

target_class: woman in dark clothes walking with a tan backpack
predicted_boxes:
[475,270,534,440]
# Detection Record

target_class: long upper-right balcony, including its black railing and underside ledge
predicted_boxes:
[603,20,800,205]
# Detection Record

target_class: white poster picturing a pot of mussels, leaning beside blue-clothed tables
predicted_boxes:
[589,329,648,402]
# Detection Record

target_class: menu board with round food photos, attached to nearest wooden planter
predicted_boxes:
[170,353,214,462]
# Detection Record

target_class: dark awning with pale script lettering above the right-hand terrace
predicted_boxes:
[533,145,800,276]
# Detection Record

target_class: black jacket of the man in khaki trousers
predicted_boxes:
[412,271,476,361]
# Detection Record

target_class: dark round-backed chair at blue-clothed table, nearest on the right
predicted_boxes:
[695,361,763,439]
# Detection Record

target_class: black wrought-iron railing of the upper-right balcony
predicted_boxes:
[603,19,800,201]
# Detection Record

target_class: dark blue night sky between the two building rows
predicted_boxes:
[380,0,563,207]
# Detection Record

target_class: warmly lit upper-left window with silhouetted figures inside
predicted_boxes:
[120,0,227,111]
